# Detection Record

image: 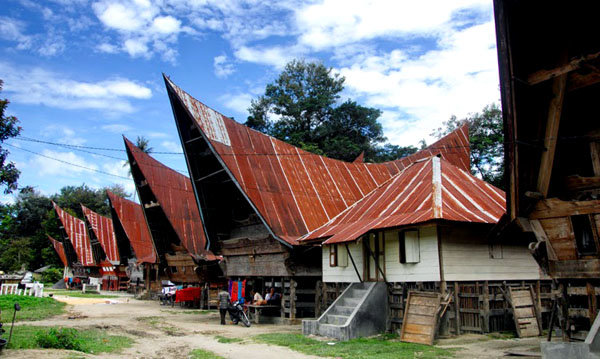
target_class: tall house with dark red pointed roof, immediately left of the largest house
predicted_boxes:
[124,138,220,289]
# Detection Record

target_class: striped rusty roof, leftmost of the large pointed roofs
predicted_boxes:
[52,202,96,267]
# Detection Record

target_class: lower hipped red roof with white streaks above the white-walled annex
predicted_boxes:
[303,156,506,244]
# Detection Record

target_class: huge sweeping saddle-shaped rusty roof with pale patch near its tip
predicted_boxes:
[165,77,470,245]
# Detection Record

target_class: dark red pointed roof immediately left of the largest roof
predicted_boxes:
[125,138,217,260]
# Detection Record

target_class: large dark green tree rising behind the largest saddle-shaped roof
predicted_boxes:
[245,60,385,161]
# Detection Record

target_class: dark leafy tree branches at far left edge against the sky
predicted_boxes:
[0,80,21,194]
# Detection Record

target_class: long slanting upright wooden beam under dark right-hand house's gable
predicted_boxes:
[538,74,567,197]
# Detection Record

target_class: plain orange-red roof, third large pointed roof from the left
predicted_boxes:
[106,191,156,263]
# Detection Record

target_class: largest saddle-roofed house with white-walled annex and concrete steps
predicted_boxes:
[165,78,540,332]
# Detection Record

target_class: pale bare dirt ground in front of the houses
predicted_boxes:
[3,295,541,359]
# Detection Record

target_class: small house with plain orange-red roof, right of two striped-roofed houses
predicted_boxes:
[106,191,157,288]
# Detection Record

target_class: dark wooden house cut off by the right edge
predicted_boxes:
[495,0,600,335]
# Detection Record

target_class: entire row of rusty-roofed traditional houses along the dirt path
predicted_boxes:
[53,0,600,344]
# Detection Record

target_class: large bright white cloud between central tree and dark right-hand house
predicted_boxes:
[340,21,500,145]
